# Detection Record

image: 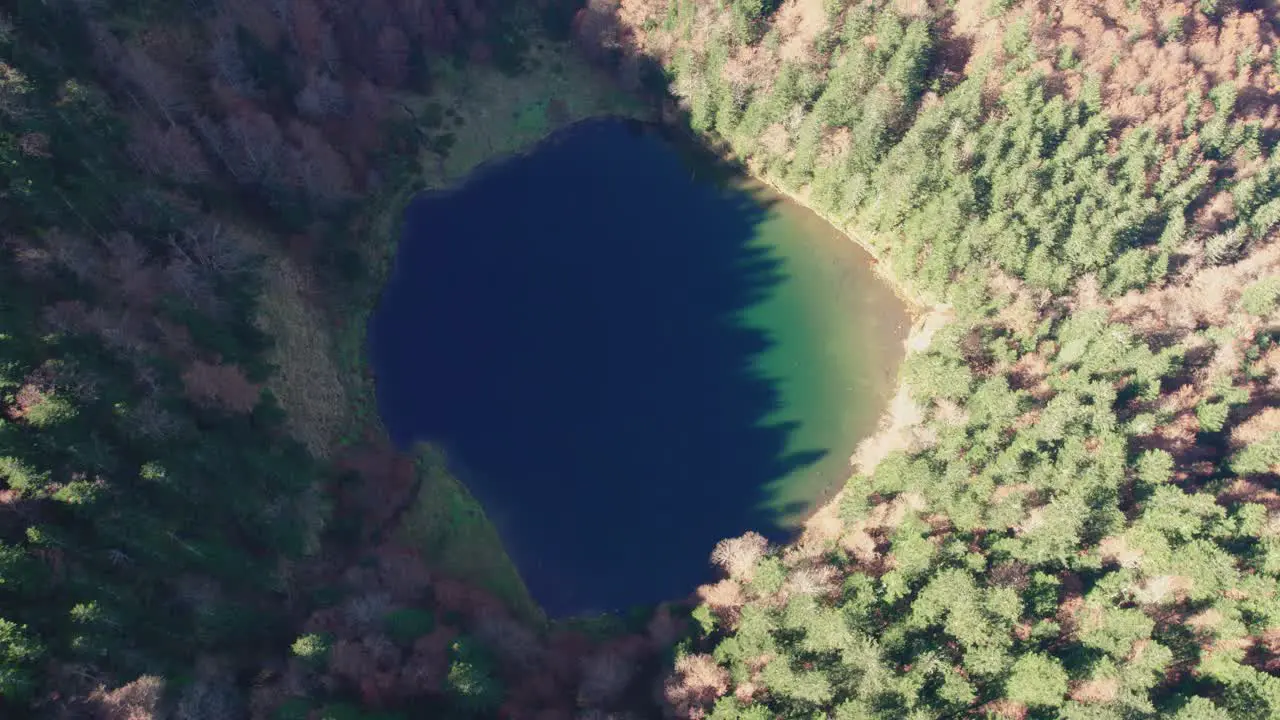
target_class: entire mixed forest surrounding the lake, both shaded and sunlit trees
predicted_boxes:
[0,0,1280,720]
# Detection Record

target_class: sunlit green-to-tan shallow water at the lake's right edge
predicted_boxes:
[741,183,910,525]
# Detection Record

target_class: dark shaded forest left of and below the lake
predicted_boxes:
[0,0,678,720]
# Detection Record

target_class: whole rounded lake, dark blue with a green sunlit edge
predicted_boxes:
[370,120,910,616]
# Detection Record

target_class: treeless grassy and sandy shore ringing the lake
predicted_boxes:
[268,32,945,621]
